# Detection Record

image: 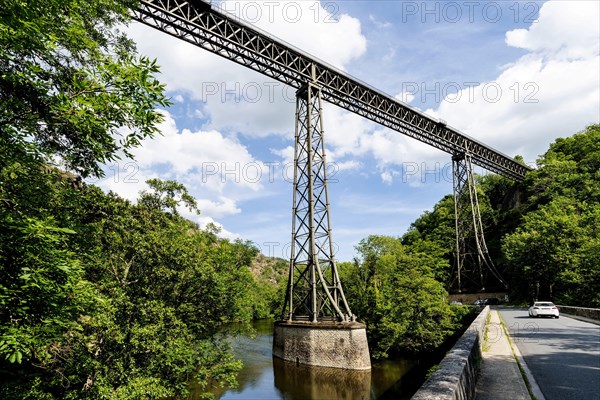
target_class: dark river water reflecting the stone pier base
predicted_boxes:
[192,320,433,400]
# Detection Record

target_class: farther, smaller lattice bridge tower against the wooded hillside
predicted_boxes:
[450,153,506,292]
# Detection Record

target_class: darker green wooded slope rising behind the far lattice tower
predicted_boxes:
[396,125,600,307]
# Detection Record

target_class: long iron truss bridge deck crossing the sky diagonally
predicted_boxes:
[132,0,530,180]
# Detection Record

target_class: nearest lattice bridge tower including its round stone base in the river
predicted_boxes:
[273,82,371,369]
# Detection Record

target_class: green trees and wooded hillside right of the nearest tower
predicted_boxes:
[340,125,600,357]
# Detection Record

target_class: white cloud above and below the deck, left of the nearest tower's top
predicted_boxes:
[128,1,367,137]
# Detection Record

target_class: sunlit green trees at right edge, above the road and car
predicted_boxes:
[503,125,600,307]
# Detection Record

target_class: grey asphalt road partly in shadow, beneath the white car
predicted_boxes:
[499,308,600,400]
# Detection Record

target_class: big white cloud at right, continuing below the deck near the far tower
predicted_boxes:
[342,1,600,172]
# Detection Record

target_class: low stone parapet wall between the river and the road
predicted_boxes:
[412,306,490,400]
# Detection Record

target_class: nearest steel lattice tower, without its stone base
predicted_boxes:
[282,82,355,322]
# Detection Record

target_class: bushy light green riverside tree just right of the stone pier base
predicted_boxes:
[340,236,464,358]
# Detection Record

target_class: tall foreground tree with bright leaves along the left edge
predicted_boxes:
[0,0,168,390]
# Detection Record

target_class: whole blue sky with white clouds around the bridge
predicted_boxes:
[92,0,600,261]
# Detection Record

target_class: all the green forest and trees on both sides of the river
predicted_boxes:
[0,0,600,399]
